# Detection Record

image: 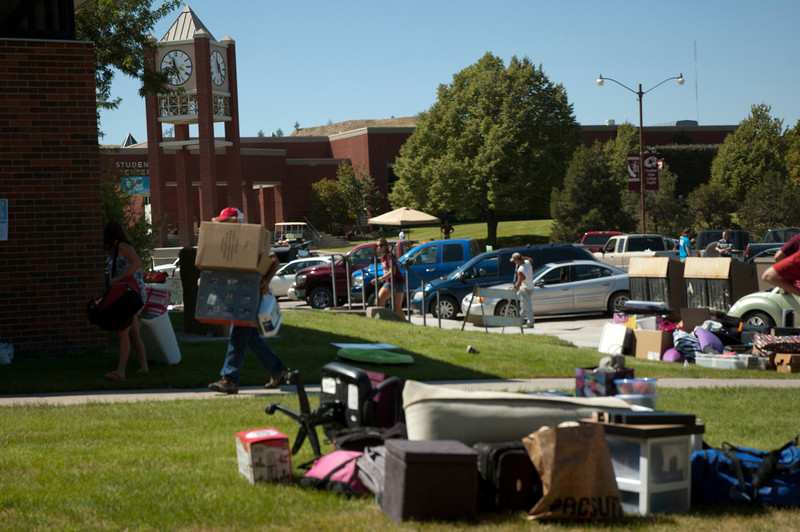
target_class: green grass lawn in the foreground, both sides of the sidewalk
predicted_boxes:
[0,300,800,531]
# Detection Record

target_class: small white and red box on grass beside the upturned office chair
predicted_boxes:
[236,427,292,484]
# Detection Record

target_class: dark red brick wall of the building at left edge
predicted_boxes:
[0,39,108,355]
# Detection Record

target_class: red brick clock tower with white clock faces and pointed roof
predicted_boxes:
[145,6,244,246]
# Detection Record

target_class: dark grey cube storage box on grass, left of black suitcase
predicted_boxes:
[381,439,478,522]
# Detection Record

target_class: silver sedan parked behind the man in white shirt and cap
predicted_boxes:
[461,260,630,321]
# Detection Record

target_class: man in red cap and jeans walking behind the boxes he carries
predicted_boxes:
[208,207,289,394]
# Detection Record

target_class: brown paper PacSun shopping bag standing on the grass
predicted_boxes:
[522,421,622,520]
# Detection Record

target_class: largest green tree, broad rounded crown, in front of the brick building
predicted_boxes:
[390,53,581,244]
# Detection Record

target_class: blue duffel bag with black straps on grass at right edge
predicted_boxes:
[692,437,800,508]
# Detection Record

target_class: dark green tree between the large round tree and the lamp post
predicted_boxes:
[550,142,633,242]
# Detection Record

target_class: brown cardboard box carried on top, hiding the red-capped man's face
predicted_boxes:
[194,222,270,275]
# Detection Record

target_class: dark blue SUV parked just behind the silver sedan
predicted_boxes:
[410,244,597,319]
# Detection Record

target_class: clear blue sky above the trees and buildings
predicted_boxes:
[100,0,800,144]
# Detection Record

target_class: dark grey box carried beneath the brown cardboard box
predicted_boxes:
[195,270,262,327]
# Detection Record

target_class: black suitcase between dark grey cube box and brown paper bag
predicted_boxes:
[474,440,542,511]
